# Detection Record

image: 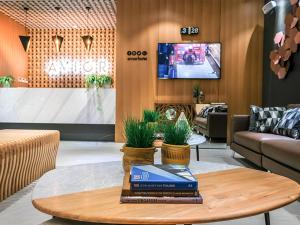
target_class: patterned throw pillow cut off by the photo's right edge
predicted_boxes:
[273,108,300,139]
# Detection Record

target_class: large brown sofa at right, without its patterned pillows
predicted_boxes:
[231,105,300,183]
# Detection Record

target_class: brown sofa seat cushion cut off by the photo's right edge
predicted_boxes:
[261,139,300,171]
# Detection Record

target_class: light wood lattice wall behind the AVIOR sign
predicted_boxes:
[28,29,115,88]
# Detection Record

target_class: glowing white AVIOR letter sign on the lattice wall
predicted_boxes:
[44,57,111,76]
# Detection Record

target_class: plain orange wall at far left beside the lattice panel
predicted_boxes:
[0,13,28,87]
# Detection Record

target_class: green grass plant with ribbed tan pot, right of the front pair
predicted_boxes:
[161,123,191,165]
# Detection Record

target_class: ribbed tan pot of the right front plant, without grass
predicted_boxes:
[161,143,191,166]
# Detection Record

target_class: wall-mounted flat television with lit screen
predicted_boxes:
[158,43,221,79]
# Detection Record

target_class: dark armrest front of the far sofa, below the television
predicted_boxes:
[207,112,228,138]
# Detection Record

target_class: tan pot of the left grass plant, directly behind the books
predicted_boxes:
[121,146,156,172]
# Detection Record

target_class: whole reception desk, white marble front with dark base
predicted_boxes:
[0,88,116,141]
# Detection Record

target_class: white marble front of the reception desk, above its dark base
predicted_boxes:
[0,88,116,124]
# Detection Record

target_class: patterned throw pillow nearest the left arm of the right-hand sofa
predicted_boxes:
[249,106,286,133]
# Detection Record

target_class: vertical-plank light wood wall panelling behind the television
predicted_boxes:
[115,0,264,141]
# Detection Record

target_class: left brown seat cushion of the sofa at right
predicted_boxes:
[233,131,291,153]
